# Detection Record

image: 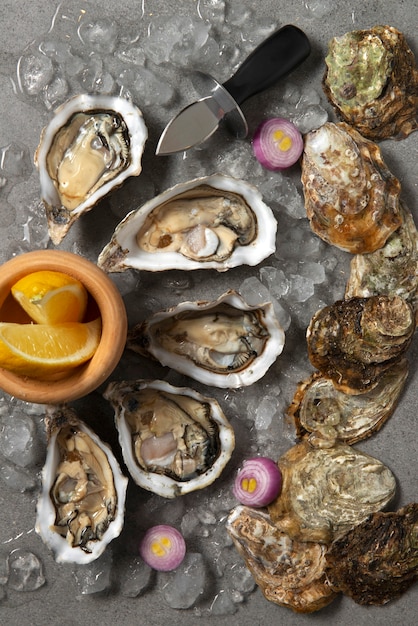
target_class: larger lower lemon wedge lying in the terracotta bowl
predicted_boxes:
[0,319,101,379]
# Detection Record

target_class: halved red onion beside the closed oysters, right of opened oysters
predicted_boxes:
[233,456,282,507]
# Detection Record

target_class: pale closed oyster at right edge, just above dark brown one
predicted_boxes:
[345,203,418,313]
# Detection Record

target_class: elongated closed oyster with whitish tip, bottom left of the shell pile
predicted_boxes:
[226,506,336,613]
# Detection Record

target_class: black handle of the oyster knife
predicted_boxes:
[222,24,311,105]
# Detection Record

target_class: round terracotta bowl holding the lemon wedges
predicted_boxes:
[0,250,127,404]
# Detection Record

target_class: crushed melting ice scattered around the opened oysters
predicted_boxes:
[0,0,350,617]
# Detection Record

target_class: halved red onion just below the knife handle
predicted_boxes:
[253,117,303,170]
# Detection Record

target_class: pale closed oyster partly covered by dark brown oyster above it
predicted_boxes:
[288,359,408,447]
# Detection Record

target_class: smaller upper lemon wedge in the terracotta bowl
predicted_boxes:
[11,270,87,324]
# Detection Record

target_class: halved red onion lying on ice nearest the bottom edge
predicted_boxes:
[139,524,186,572]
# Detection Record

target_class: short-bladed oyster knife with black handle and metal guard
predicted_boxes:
[156,24,311,155]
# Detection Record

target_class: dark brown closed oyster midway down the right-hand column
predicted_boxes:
[307,296,415,393]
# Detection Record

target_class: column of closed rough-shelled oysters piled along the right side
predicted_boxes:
[227,26,418,613]
